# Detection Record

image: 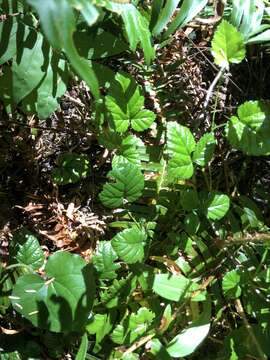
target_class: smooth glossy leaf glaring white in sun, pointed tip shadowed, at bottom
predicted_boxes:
[166,301,211,358]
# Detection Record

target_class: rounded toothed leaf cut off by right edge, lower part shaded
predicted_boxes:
[226,101,270,156]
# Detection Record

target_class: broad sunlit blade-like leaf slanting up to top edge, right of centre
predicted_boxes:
[162,0,208,39]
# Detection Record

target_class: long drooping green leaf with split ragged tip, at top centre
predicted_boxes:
[106,1,155,65]
